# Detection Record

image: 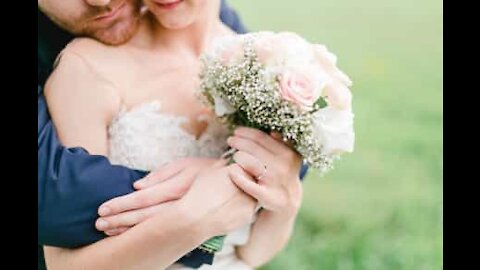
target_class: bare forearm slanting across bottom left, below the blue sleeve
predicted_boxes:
[45,202,209,270]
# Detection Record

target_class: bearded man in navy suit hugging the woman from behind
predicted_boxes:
[38,0,305,267]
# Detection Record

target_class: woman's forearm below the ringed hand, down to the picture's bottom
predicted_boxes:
[237,210,296,268]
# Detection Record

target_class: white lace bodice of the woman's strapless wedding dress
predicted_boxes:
[108,101,228,171]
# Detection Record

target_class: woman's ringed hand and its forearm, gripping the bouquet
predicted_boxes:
[228,127,303,268]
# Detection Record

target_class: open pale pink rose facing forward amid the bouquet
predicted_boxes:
[280,68,325,110]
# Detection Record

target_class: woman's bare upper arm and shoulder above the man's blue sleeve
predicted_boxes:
[44,47,121,156]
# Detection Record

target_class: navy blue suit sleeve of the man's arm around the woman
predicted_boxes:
[38,85,146,248]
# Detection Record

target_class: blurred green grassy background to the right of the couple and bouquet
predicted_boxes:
[228,0,443,270]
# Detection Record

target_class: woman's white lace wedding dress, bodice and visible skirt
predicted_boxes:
[108,101,253,270]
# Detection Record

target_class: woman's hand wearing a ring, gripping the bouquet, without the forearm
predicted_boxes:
[228,127,302,218]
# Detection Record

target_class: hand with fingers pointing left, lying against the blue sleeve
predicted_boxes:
[95,158,225,236]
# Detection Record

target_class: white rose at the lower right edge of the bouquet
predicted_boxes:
[314,106,355,155]
